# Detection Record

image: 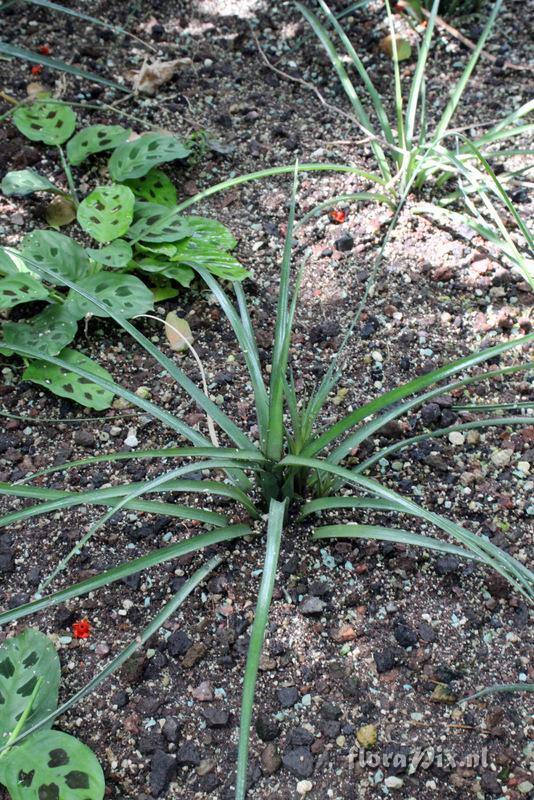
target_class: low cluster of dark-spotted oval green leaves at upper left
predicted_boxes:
[0,98,248,409]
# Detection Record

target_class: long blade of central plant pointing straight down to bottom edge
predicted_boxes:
[235,500,287,800]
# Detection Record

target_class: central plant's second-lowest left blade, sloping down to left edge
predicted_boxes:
[0,525,251,625]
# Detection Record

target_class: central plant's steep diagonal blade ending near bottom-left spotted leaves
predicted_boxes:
[0,556,223,754]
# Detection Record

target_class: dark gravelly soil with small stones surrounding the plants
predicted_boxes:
[0,0,534,800]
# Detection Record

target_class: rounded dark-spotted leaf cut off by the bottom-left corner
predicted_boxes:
[0,731,106,800]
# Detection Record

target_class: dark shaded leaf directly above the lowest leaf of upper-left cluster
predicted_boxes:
[0,305,78,356]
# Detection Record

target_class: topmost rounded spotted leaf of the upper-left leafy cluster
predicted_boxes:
[13,100,76,145]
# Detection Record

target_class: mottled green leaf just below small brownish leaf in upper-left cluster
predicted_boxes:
[21,230,91,283]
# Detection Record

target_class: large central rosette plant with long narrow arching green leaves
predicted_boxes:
[0,170,534,800]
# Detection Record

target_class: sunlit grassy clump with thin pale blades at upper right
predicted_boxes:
[296,0,534,289]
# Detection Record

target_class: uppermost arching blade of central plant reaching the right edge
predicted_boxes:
[303,333,534,456]
